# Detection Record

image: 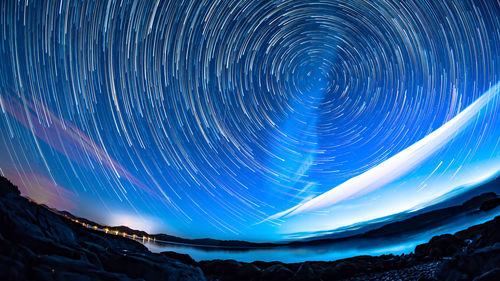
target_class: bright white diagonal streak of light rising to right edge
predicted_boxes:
[270,82,500,219]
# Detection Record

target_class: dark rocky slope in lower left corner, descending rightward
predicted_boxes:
[0,178,205,281]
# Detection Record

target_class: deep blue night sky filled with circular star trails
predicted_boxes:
[0,0,500,241]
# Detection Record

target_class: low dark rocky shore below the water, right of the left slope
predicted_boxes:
[198,216,500,281]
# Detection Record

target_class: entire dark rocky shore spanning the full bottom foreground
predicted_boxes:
[0,178,500,281]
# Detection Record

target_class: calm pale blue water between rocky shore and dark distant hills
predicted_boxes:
[144,208,500,263]
